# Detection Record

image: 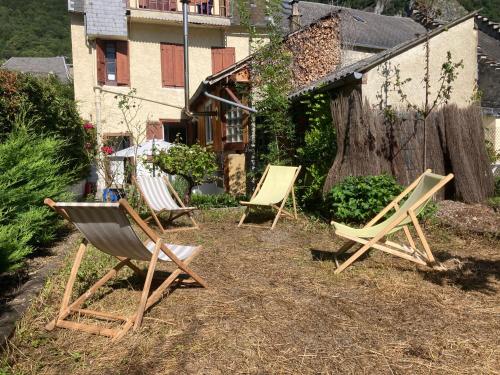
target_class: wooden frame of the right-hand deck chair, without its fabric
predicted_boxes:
[335,169,453,274]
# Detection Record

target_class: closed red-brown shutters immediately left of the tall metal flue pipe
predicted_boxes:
[160,43,184,87]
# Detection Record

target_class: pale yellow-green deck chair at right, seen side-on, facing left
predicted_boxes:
[332,169,453,273]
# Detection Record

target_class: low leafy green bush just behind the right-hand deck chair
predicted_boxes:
[325,175,403,223]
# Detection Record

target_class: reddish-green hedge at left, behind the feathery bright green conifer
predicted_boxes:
[0,70,89,176]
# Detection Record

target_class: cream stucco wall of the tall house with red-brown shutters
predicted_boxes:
[71,14,249,138]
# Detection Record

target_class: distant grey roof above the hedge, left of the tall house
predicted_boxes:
[2,56,70,82]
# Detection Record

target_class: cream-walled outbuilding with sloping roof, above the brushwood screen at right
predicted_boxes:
[290,10,477,110]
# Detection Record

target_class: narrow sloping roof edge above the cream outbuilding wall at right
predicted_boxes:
[289,12,476,100]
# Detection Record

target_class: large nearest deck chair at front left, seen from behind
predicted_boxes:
[45,198,207,341]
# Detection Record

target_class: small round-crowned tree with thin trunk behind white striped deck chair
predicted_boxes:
[153,143,219,203]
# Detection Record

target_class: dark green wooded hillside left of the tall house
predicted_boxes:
[0,0,71,61]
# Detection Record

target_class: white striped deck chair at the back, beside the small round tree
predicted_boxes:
[133,176,199,233]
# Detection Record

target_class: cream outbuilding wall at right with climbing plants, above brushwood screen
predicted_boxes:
[362,18,477,107]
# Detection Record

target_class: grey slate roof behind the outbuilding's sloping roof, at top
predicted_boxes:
[283,1,425,50]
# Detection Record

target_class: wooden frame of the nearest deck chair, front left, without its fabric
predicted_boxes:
[45,198,207,341]
